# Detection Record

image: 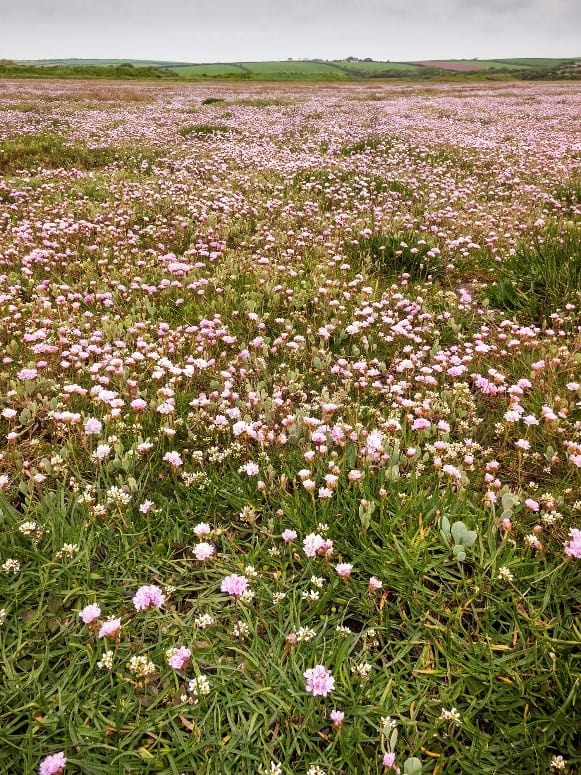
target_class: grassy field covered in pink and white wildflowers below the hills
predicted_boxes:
[0,81,581,775]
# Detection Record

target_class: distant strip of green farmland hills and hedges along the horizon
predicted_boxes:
[0,57,581,81]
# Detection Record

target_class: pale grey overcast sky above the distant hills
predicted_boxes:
[0,0,581,62]
